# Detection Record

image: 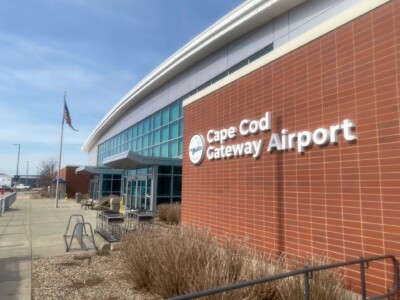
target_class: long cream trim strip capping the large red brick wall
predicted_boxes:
[183,0,390,106]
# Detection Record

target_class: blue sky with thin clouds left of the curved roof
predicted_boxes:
[0,0,243,175]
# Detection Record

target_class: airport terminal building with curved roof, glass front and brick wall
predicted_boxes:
[80,0,400,295]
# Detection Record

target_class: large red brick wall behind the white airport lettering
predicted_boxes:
[182,0,400,292]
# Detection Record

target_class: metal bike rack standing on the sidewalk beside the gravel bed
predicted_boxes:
[64,215,97,252]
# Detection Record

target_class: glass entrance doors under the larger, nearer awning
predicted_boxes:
[126,176,152,210]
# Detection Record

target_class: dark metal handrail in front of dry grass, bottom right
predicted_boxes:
[169,255,399,300]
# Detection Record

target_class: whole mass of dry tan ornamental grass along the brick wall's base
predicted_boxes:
[119,226,359,300]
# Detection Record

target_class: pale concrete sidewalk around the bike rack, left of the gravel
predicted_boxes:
[0,192,104,300]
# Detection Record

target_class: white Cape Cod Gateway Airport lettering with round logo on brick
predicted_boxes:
[189,112,357,164]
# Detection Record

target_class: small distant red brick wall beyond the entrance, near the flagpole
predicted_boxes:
[60,166,90,198]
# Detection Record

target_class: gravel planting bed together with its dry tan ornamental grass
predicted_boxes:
[32,206,360,300]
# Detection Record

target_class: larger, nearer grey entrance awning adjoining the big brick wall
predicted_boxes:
[103,151,182,169]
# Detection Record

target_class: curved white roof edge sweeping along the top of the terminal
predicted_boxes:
[82,0,305,152]
